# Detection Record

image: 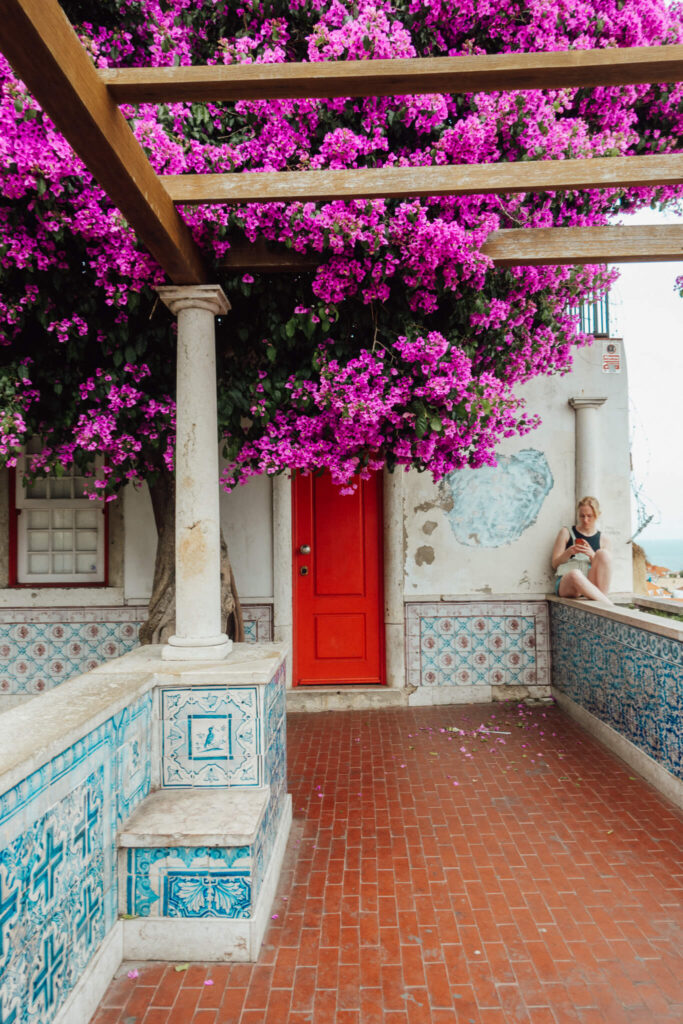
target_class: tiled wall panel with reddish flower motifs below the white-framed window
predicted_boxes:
[0,604,272,694]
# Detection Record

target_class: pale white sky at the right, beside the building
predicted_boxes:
[609,210,683,542]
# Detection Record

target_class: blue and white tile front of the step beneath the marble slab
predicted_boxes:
[126,846,252,918]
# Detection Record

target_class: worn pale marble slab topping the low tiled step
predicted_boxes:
[119,786,270,847]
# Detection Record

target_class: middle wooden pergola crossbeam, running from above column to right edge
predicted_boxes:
[160,154,683,203]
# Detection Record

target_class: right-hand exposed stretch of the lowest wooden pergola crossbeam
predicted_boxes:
[481,220,683,266]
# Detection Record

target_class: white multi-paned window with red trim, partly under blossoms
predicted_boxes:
[15,440,105,585]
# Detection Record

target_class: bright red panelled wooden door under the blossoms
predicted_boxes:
[292,473,384,686]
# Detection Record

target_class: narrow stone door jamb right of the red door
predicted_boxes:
[383,467,405,689]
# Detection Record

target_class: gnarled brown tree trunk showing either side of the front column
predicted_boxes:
[140,473,245,644]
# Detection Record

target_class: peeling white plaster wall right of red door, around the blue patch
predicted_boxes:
[403,340,633,600]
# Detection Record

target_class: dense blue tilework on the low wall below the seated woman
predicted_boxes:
[550,602,683,778]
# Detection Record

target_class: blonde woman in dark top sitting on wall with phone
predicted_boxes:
[552,497,612,604]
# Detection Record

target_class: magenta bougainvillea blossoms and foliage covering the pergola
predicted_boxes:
[0,0,683,497]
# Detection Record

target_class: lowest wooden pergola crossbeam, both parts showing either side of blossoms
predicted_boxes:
[221,220,683,273]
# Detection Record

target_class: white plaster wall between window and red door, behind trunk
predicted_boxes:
[124,468,272,601]
